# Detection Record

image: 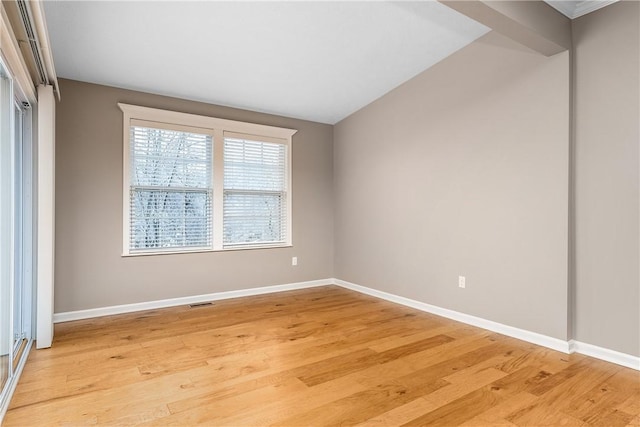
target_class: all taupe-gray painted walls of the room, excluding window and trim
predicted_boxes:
[55,2,640,356]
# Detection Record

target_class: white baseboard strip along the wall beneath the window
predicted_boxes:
[53,279,333,323]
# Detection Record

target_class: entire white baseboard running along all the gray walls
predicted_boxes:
[53,278,640,371]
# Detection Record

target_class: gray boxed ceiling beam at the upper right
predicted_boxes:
[439,0,571,56]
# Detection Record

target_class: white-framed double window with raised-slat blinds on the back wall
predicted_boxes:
[119,104,295,255]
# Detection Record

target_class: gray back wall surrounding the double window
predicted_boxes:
[55,79,333,313]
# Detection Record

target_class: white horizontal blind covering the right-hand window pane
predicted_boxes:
[223,133,288,247]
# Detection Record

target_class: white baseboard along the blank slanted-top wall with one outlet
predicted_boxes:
[334,279,569,353]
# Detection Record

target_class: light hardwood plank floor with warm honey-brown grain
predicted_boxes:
[4,286,640,426]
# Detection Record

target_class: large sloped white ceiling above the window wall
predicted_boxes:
[44,1,489,124]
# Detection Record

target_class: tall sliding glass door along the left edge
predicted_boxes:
[0,59,34,415]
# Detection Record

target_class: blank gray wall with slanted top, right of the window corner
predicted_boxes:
[334,33,569,339]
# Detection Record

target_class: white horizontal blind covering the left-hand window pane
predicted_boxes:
[129,126,213,253]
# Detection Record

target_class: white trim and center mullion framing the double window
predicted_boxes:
[118,103,297,256]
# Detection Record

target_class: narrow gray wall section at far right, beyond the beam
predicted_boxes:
[573,2,640,356]
